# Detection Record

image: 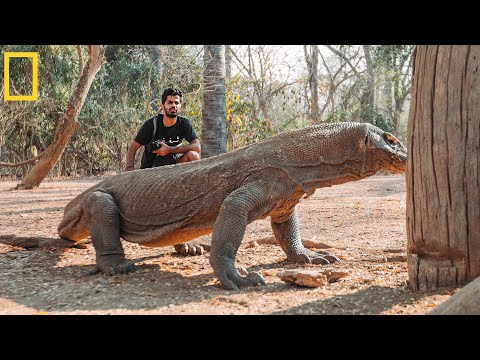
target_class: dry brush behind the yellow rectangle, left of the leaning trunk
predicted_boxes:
[0,45,79,177]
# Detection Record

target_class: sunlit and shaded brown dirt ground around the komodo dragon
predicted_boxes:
[0,175,459,315]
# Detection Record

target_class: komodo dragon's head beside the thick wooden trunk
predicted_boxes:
[365,124,407,173]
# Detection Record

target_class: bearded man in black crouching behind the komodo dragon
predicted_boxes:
[126,88,201,171]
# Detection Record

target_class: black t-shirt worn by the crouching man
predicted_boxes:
[135,114,198,169]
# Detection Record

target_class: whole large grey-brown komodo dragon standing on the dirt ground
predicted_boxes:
[58,122,406,289]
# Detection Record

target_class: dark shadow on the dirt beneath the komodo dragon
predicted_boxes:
[0,247,291,312]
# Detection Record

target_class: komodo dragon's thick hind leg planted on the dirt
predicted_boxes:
[87,191,135,275]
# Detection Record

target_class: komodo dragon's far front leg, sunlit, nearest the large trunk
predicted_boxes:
[271,207,340,264]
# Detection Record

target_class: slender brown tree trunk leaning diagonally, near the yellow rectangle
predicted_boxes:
[17,45,103,190]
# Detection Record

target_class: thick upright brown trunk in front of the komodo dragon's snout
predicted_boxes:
[406,45,480,290]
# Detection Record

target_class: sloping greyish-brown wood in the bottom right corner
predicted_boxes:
[429,277,480,315]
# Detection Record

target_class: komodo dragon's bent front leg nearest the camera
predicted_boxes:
[210,180,271,290]
